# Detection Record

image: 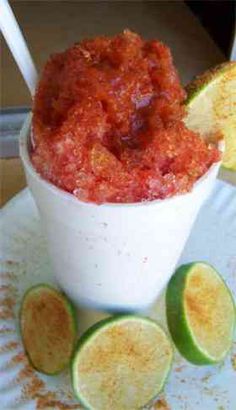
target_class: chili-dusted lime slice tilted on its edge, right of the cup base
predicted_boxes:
[166,262,235,365]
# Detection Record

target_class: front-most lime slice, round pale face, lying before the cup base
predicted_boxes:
[72,315,173,410]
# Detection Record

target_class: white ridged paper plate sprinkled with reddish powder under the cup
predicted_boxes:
[0,182,236,410]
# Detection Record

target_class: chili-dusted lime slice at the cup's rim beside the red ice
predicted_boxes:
[185,62,236,171]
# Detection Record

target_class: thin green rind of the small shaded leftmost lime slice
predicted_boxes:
[19,283,78,376]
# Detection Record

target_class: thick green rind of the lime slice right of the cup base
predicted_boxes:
[166,262,235,365]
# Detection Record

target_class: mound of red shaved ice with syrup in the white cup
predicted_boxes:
[31,30,220,203]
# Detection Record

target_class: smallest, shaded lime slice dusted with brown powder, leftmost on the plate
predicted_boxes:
[20,284,77,375]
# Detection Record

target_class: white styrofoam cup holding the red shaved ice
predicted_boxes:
[20,116,220,311]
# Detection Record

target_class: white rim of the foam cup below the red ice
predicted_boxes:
[19,112,224,208]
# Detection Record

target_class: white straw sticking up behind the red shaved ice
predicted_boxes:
[0,0,37,96]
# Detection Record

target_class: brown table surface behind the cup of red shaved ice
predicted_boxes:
[0,0,236,205]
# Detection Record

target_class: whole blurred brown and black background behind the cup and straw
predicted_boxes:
[0,0,235,204]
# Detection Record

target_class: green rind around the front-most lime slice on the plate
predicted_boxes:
[71,314,174,410]
